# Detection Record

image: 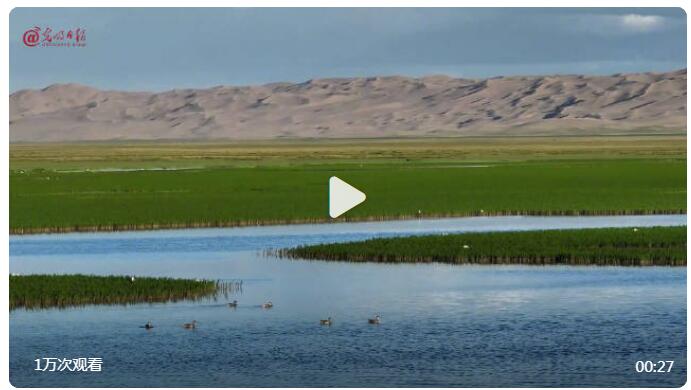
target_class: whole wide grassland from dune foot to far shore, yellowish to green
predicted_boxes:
[10,136,686,234]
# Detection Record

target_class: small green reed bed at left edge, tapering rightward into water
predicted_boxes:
[10,274,242,310]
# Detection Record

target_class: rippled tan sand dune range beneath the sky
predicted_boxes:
[10,69,686,142]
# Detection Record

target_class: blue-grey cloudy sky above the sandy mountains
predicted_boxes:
[10,8,686,92]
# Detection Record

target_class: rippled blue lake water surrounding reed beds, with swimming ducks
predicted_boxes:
[10,216,686,387]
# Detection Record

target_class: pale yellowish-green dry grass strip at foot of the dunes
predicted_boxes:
[10,136,686,171]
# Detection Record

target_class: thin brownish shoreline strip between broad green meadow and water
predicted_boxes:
[9,209,687,236]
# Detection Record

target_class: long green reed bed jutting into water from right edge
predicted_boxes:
[279,226,686,266]
